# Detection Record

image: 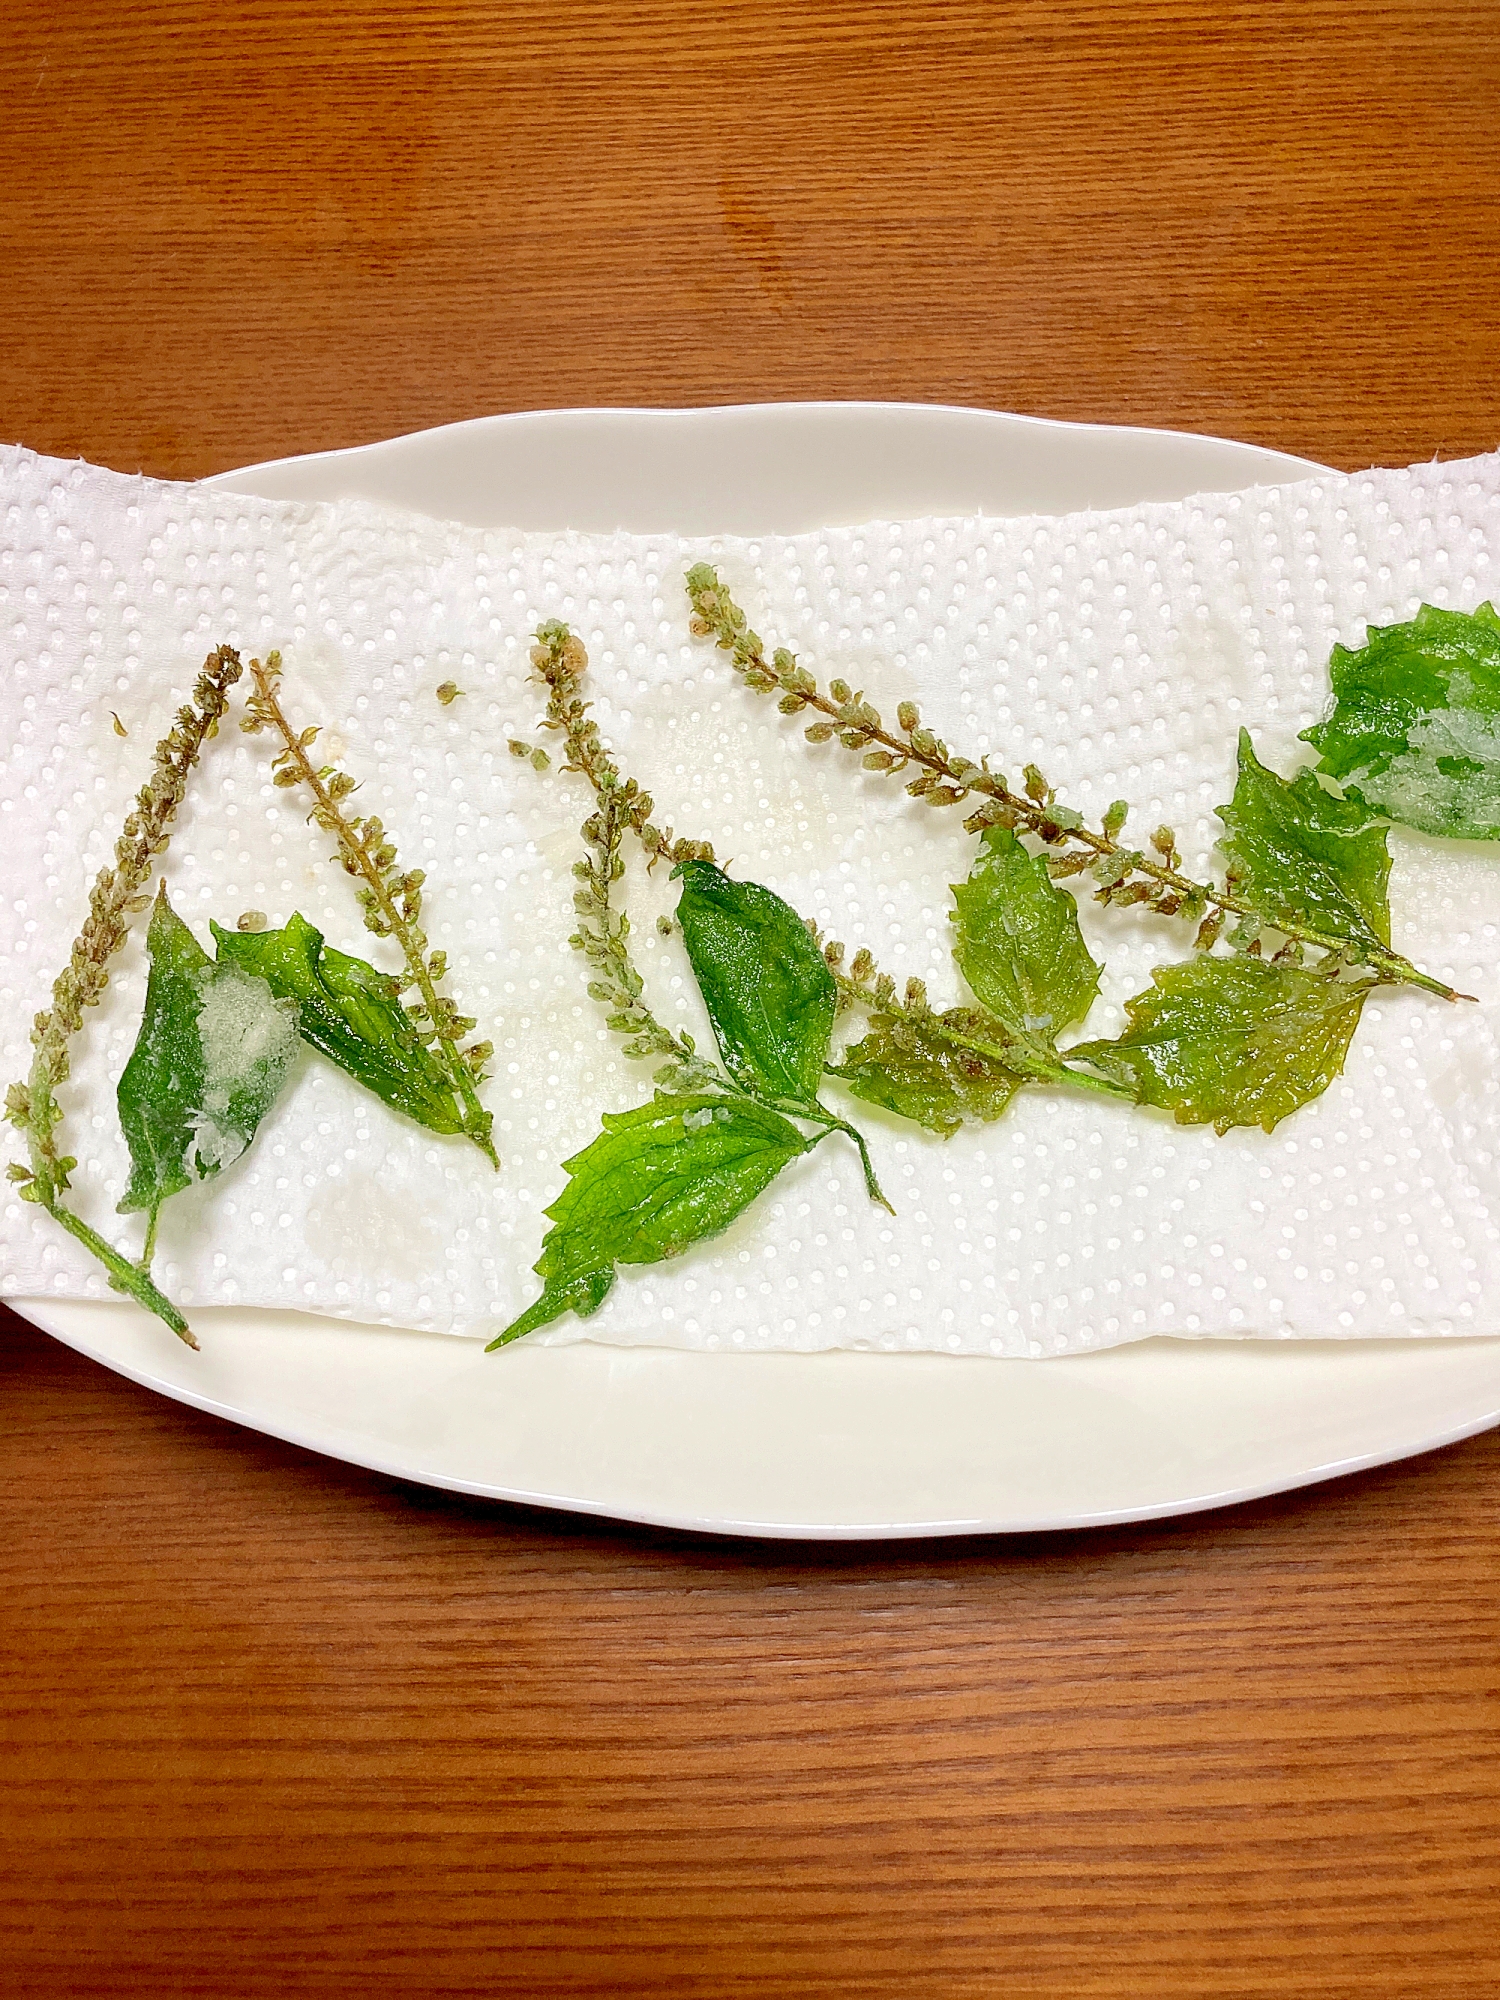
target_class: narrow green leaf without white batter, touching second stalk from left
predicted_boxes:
[212,916,464,1134]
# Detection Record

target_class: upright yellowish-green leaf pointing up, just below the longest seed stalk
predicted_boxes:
[952,826,1100,1074]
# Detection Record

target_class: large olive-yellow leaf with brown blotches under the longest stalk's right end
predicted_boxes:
[1068,958,1372,1132]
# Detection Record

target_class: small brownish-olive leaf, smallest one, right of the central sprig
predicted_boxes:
[830,1008,1026,1138]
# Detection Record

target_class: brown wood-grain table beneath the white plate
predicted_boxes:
[0,0,1500,2000]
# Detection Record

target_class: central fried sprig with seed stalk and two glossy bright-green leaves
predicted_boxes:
[490,622,912,1348]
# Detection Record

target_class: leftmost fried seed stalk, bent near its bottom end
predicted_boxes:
[6,646,242,1348]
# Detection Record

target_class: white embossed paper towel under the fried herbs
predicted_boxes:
[0,450,1500,1366]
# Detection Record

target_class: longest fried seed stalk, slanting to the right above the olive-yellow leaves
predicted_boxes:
[688,562,1472,1000]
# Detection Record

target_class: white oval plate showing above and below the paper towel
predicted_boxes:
[18,404,1500,1538]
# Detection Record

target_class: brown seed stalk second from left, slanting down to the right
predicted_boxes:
[240,652,500,1168]
